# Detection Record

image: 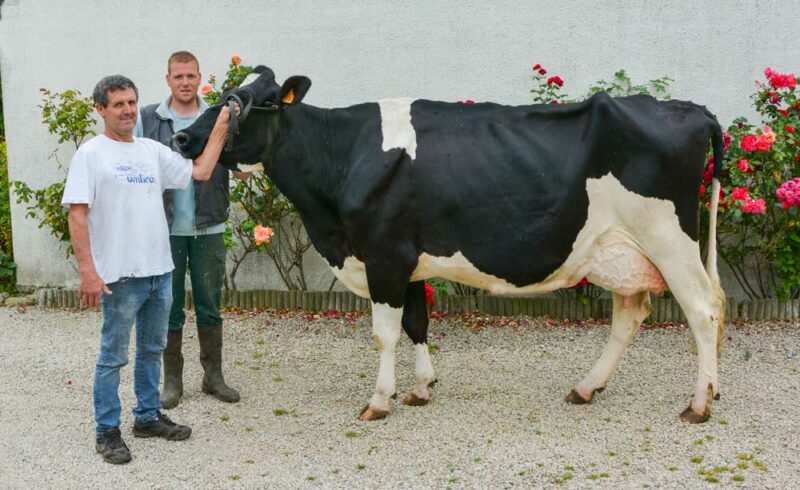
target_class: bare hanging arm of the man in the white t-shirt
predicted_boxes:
[68,204,111,308]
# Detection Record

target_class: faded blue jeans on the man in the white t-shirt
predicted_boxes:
[94,272,172,434]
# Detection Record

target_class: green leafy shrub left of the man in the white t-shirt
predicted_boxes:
[13,88,95,257]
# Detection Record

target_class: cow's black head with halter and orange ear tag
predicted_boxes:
[173,66,311,170]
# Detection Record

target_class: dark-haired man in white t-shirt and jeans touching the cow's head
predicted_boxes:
[61,75,229,464]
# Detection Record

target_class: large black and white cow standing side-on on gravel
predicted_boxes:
[175,67,724,422]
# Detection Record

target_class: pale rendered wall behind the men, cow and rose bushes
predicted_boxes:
[0,0,800,294]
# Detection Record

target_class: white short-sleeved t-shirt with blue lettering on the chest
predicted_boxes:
[61,134,192,284]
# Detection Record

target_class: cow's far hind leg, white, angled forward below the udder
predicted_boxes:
[565,291,650,404]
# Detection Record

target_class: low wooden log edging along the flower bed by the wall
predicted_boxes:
[32,288,800,323]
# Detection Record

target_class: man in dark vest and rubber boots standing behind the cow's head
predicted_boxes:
[136,51,250,408]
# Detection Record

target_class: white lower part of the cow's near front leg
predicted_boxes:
[359,303,403,420]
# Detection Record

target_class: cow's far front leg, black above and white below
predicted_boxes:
[402,281,436,406]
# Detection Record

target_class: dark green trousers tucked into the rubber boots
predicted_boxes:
[169,233,226,330]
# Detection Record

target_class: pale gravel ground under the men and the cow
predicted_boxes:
[0,307,800,489]
